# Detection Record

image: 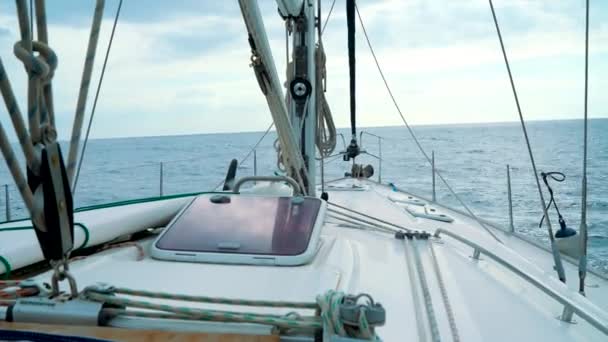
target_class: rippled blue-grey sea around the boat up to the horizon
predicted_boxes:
[0,119,608,271]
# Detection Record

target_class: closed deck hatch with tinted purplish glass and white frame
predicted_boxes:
[152,194,325,265]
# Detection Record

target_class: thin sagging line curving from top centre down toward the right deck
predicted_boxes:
[355,4,503,243]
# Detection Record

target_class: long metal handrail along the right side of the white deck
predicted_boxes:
[434,228,608,335]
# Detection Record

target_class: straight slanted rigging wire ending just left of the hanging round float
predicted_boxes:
[488,0,566,283]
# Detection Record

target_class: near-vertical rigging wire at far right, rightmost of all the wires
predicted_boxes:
[578,0,589,296]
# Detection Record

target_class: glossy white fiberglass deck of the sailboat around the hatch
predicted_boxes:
[1,179,608,341]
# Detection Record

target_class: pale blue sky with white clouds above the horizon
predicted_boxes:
[0,0,608,139]
